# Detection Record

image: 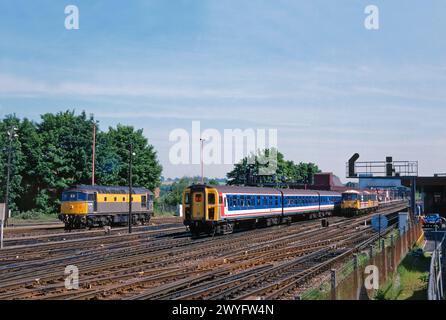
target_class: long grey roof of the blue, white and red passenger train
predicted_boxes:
[190,185,341,196]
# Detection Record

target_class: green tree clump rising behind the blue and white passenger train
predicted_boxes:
[227,149,320,185]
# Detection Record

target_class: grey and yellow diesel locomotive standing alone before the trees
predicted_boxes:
[59,185,153,229]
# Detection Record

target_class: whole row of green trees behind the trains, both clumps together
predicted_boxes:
[0,110,320,213]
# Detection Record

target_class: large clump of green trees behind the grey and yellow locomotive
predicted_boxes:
[0,110,162,213]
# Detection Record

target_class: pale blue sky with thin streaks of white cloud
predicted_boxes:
[0,0,446,178]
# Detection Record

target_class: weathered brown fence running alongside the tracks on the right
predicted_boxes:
[299,218,423,300]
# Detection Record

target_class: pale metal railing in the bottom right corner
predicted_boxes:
[427,231,446,300]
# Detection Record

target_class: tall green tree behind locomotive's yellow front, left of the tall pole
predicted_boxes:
[36,111,94,212]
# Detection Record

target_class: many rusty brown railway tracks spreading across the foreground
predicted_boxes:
[0,202,408,299]
